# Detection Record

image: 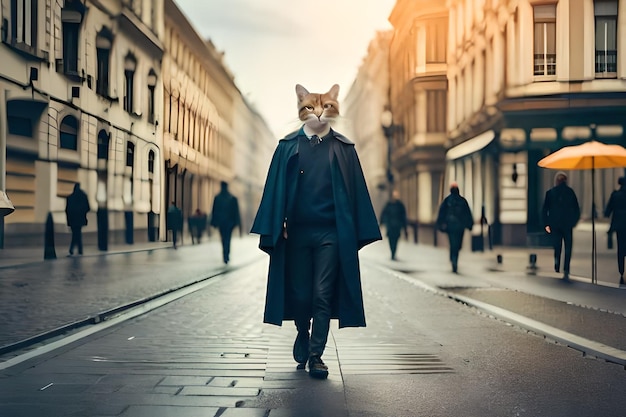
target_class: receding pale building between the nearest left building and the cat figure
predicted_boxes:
[162,0,274,237]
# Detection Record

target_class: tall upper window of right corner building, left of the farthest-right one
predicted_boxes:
[533,4,556,75]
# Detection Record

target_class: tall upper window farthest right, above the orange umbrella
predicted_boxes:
[594,0,617,77]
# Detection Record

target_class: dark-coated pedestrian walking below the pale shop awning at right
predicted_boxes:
[437,182,474,273]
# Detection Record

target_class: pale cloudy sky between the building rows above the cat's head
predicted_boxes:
[175,0,396,137]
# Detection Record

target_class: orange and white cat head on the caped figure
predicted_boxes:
[296,84,339,131]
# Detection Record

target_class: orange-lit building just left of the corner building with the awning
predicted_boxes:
[388,0,448,243]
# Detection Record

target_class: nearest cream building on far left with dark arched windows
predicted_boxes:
[0,0,163,249]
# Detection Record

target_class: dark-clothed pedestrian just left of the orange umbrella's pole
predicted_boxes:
[542,171,580,280]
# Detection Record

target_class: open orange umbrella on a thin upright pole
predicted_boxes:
[537,140,626,283]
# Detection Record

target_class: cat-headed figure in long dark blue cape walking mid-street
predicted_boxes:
[251,85,382,378]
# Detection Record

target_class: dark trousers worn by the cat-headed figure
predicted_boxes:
[286,226,339,356]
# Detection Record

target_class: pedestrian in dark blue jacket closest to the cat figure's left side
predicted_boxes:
[211,181,241,264]
